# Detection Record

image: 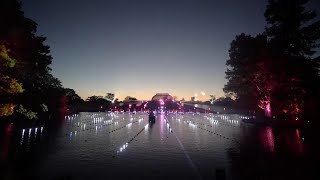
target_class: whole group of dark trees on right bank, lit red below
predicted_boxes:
[224,0,320,125]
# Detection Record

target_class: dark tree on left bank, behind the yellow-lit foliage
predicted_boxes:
[0,0,80,117]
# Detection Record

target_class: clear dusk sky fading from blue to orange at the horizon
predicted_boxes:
[22,0,319,100]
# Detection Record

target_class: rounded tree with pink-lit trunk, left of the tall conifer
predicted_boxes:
[223,34,274,116]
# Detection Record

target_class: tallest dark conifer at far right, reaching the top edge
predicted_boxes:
[265,0,320,120]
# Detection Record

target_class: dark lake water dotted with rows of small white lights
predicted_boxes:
[0,113,320,180]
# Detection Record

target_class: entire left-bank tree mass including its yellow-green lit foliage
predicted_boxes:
[0,0,81,122]
